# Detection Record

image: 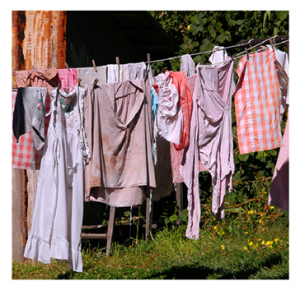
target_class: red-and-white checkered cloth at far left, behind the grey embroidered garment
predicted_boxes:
[11,90,50,170]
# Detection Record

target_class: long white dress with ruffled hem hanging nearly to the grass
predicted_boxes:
[24,86,89,272]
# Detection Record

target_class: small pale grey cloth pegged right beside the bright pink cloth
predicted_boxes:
[77,66,107,85]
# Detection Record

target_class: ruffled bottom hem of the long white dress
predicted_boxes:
[24,236,83,272]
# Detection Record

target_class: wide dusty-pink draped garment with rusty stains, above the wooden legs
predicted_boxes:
[84,79,156,207]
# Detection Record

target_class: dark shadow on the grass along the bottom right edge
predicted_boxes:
[147,255,289,280]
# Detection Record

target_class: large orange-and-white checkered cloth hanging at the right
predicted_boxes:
[234,50,282,154]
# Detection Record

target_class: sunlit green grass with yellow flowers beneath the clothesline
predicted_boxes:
[12,208,289,279]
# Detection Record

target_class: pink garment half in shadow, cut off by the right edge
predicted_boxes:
[268,119,289,212]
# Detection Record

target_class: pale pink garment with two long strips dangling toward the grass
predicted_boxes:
[180,57,235,239]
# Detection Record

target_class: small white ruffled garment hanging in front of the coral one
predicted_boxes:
[154,71,183,145]
